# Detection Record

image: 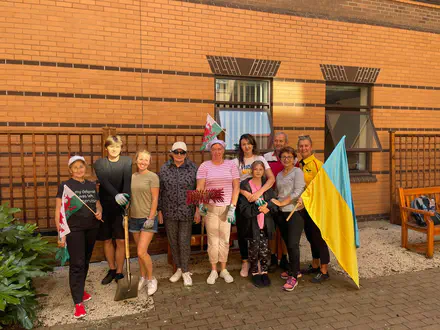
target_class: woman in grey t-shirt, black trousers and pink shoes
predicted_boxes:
[272,147,306,291]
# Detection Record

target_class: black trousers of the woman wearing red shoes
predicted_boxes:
[66,228,99,304]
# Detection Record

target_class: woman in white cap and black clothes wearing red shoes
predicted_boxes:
[55,156,102,318]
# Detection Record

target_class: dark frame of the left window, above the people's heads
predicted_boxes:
[214,75,274,154]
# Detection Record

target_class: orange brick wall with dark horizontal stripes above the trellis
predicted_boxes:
[0,0,440,215]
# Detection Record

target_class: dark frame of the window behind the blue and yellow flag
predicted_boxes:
[324,82,382,176]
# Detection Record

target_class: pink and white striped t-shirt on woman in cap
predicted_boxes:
[197,159,240,206]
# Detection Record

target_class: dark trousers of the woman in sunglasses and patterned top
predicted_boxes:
[165,220,192,273]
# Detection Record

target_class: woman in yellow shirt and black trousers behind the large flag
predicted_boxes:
[298,135,330,283]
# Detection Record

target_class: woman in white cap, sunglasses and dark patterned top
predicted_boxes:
[158,141,200,286]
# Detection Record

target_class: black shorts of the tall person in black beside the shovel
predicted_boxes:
[96,202,125,241]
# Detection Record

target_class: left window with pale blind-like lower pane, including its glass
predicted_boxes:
[215,78,272,150]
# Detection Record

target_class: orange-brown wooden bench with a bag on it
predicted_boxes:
[399,187,440,258]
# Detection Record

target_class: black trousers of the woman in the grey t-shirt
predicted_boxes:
[275,212,304,278]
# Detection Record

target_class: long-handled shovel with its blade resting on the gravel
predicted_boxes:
[115,205,139,301]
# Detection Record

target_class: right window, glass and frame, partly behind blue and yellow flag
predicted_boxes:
[324,85,382,174]
